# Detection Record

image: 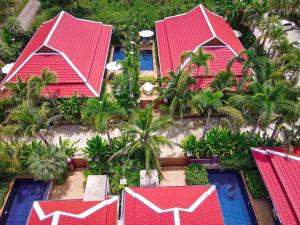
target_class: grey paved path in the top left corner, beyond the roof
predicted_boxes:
[18,0,41,30]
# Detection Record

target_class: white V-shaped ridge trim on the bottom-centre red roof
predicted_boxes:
[125,185,216,225]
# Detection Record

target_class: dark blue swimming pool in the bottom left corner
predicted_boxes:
[0,179,50,225]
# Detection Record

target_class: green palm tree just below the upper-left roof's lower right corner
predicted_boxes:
[83,93,126,148]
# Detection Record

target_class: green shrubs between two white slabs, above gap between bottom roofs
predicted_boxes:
[109,159,143,194]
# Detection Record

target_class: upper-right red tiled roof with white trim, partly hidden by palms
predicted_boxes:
[155,5,244,87]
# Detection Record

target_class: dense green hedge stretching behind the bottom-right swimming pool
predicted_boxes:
[181,128,280,169]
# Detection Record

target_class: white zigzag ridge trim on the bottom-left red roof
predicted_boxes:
[33,196,118,225]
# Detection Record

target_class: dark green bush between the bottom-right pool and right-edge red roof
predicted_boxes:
[244,170,268,198]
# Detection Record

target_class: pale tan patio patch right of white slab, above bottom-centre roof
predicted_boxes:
[160,167,186,186]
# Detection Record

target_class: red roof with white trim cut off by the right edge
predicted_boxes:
[252,147,300,225]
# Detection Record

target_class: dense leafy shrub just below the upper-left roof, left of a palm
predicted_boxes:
[59,95,85,123]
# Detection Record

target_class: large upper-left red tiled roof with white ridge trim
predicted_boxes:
[1,11,112,97]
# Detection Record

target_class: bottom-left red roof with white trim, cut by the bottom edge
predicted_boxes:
[27,197,118,225]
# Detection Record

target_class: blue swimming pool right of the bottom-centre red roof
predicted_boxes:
[208,170,257,225]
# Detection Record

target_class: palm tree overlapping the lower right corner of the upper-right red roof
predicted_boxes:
[227,48,264,92]
